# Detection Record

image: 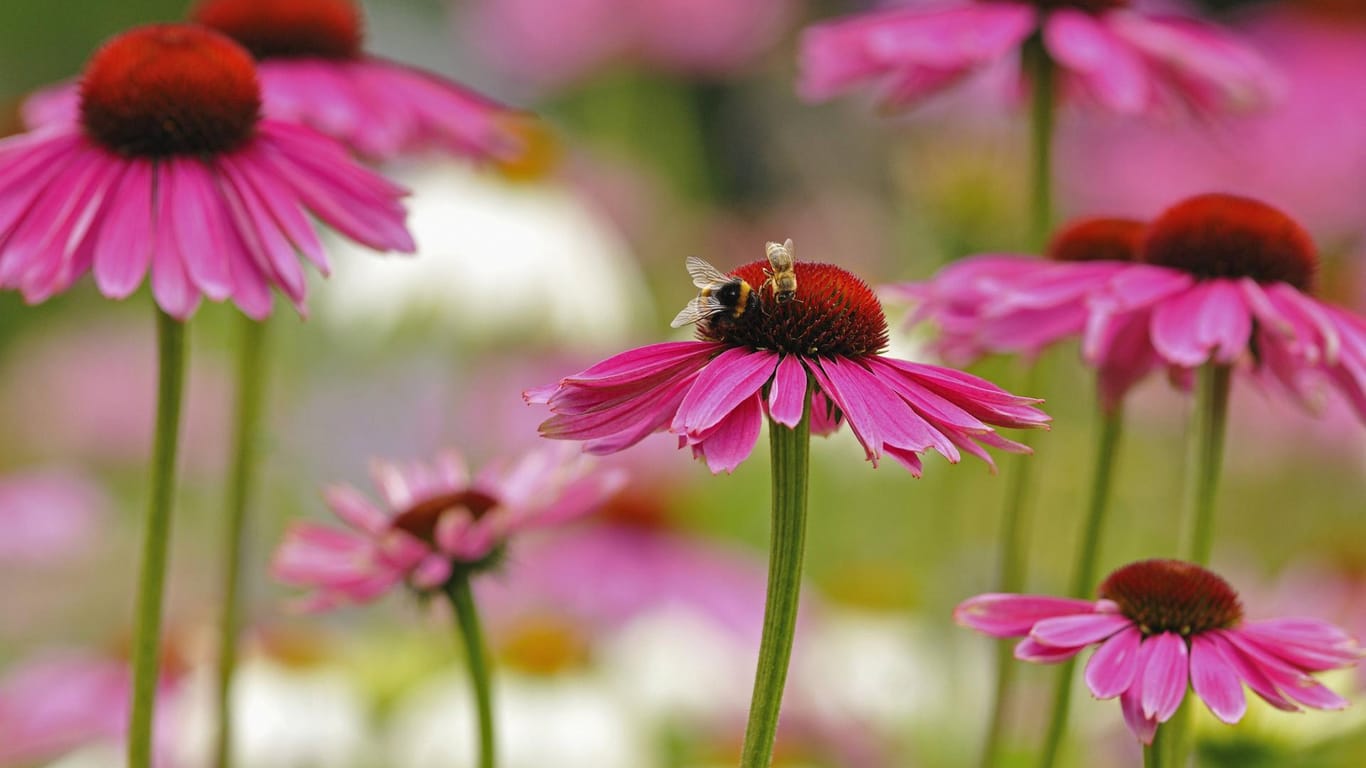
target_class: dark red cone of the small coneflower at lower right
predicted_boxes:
[1100,560,1243,637]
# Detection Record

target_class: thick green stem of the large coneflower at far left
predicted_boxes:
[128,309,184,768]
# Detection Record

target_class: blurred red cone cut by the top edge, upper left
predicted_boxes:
[191,0,363,59]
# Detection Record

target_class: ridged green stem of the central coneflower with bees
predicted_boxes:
[740,384,811,768]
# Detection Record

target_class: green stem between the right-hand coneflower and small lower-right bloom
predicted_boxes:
[1188,362,1232,566]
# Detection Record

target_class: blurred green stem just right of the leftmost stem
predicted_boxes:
[213,314,266,768]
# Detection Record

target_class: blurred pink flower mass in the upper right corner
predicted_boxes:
[1057,1,1366,239]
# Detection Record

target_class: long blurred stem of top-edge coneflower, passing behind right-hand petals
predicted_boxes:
[981,33,1057,768]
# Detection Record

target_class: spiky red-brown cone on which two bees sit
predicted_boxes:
[698,260,887,357]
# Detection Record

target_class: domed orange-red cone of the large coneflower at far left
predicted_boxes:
[81,25,261,157]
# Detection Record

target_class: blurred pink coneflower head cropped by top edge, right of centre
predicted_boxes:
[799,0,1277,115]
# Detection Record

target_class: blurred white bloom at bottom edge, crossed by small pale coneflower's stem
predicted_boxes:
[385,670,654,768]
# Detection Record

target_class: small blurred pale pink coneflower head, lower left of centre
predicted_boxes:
[273,452,623,609]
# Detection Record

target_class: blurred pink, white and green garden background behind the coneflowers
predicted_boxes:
[0,0,1366,768]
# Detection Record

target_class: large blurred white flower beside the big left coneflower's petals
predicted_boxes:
[320,161,647,348]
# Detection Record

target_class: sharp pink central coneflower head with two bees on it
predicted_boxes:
[525,243,1048,474]
